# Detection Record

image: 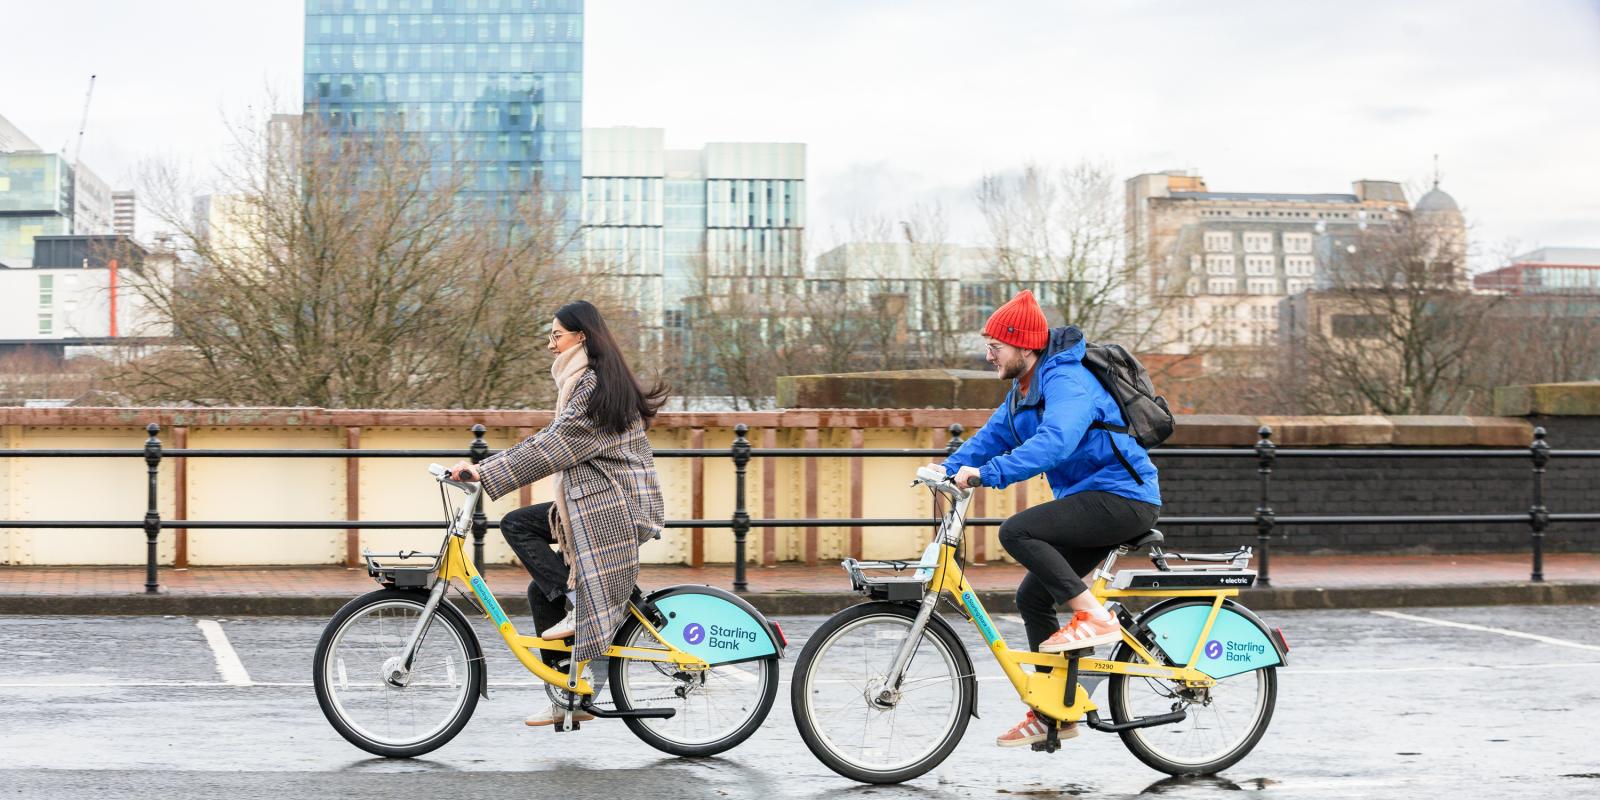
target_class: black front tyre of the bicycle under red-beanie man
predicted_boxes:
[789,602,978,784]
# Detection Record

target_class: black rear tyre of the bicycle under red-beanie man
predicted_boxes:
[1107,598,1278,776]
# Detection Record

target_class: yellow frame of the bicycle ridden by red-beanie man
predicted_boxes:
[886,480,1238,722]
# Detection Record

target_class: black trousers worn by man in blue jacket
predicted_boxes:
[1000,491,1162,650]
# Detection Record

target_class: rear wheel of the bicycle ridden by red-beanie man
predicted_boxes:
[1107,600,1278,774]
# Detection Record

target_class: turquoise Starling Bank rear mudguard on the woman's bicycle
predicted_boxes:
[645,584,784,664]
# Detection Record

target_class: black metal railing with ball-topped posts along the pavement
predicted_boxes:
[0,422,1600,592]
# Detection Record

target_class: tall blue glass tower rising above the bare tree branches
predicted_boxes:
[306,0,584,221]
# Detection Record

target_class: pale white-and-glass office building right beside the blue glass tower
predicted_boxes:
[582,128,805,344]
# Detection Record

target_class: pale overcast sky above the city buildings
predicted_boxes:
[0,0,1600,262]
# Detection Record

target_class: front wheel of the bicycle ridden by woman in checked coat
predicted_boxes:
[312,589,483,758]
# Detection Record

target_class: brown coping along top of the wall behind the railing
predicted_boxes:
[0,403,1548,448]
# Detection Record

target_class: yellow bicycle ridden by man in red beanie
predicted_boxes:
[790,467,1288,784]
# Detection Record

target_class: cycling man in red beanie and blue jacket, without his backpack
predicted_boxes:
[939,290,1162,747]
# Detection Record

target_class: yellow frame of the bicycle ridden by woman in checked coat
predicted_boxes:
[377,478,709,696]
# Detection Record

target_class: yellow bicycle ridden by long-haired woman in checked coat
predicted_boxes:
[312,464,787,758]
